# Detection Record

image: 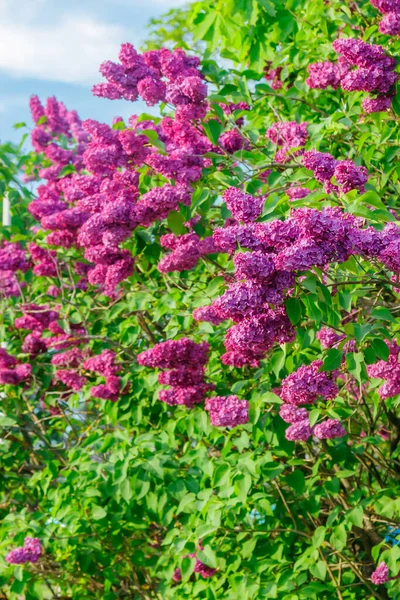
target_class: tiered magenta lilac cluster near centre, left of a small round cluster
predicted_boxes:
[137,338,214,408]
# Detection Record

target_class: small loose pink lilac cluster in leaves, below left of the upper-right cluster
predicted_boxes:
[266,121,308,163]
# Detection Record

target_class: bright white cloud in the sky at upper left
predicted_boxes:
[0,12,134,86]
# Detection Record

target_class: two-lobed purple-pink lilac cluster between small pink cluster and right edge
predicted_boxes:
[303,150,368,194]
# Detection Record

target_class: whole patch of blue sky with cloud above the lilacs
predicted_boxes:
[0,0,185,141]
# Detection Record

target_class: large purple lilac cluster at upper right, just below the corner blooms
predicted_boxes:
[306,38,400,113]
